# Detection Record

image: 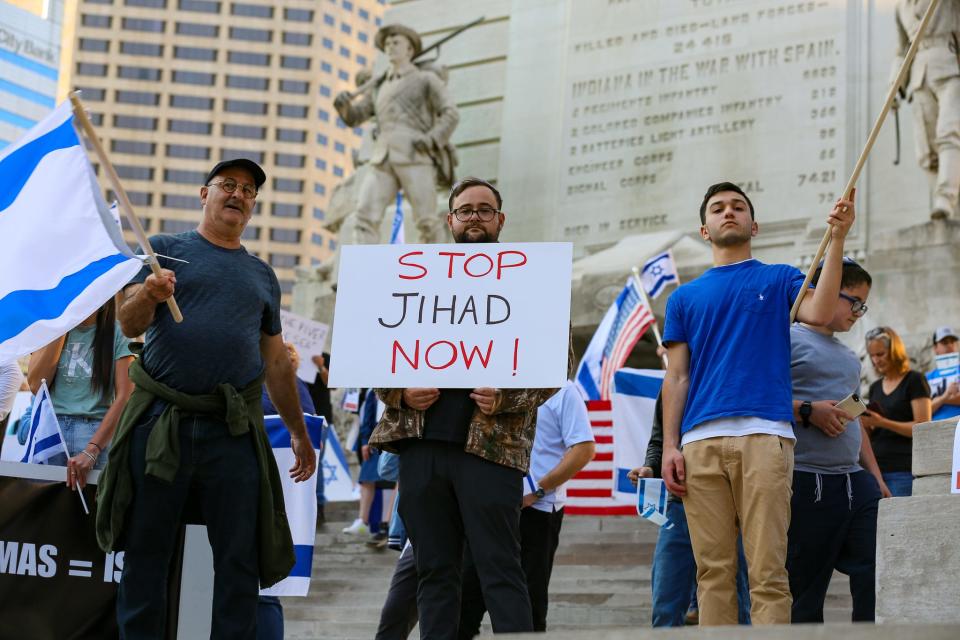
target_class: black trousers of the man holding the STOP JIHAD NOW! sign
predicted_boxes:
[399,440,533,640]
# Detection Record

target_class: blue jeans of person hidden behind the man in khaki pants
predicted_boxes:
[650,502,750,627]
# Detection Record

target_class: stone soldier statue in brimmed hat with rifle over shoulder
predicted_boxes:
[333,24,459,244]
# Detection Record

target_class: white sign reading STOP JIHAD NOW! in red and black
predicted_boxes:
[330,242,572,388]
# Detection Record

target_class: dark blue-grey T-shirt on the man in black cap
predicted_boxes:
[130,231,280,394]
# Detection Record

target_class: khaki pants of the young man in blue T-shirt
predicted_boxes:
[683,434,793,625]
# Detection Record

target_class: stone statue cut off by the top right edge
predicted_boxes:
[893,0,960,219]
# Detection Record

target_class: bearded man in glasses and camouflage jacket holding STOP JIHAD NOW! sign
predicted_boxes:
[370,178,556,638]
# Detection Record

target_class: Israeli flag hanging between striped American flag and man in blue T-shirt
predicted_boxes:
[610,368,665,504]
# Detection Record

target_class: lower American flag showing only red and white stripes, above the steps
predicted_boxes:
[563,400,637,516]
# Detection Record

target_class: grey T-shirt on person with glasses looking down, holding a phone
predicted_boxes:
[790,324,861,474]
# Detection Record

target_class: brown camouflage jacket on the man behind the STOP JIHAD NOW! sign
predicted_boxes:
[370,389,557,473]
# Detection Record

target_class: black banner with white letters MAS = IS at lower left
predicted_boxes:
[0,476,123,640]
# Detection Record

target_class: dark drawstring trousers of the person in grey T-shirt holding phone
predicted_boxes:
[787,471,880,623]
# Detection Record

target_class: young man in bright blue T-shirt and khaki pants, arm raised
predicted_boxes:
[662,182,854,625]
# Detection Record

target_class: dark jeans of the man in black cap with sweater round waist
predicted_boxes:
[117,415,260,640]
